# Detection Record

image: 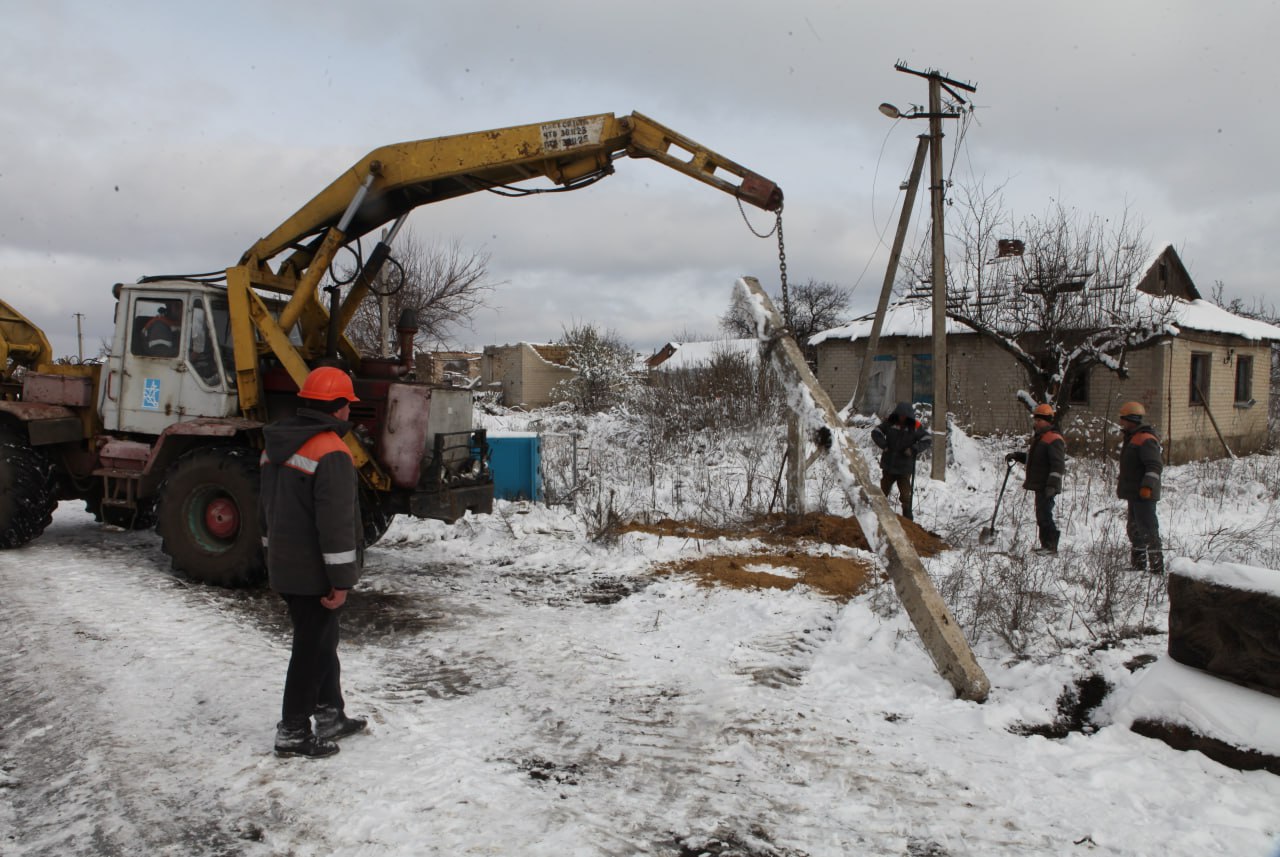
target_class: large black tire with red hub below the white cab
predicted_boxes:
[156,446,266,587]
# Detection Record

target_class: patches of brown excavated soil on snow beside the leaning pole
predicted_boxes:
[621,513,948,601]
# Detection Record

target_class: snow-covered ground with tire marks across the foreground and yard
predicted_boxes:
[0,437,1280,857]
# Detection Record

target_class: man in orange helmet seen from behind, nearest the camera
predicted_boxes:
[259,366,367,757]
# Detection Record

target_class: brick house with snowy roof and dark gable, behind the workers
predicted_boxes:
[809,246,1280,463]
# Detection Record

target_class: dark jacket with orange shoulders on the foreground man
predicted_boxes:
[259,408,364,595]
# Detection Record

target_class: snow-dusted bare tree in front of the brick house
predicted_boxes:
[905,187,1172,427]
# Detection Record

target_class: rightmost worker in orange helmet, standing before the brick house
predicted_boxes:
[1116,402,1165,574]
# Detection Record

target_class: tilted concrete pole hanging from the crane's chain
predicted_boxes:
[733,276,991,702]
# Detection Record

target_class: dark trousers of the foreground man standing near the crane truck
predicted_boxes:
[280,595,346,730]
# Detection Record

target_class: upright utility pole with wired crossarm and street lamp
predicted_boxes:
[880,63,978,482]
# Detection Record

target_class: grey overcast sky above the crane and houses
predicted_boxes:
[0,0,1280,356]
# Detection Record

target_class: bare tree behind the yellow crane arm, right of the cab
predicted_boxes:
[344,230,499,354]
